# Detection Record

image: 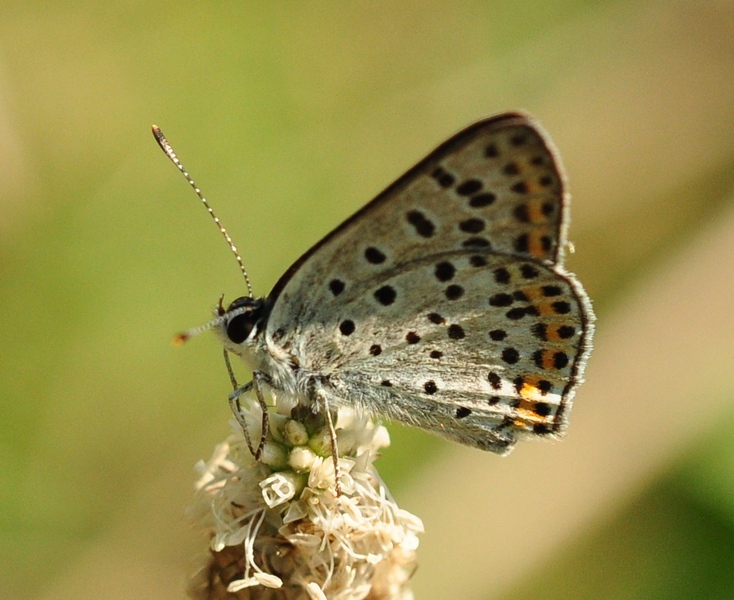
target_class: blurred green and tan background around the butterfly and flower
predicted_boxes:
[0,0,734,600]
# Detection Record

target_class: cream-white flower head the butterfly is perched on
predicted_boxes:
[189,396,423,600]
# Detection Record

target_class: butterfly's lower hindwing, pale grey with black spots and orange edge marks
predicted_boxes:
[304,251,584,451]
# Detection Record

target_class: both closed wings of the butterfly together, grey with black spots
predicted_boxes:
[266,114,593,453]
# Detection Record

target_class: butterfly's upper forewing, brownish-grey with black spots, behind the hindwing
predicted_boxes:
[271,114,565,330]
